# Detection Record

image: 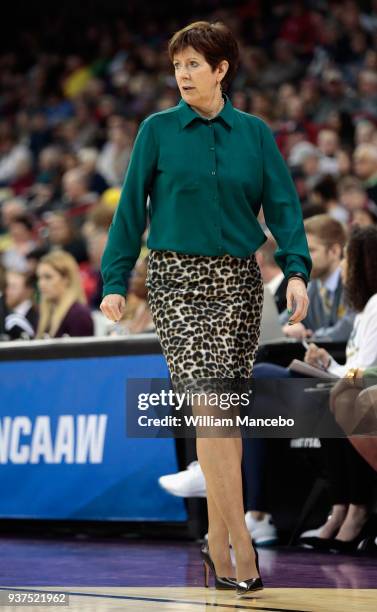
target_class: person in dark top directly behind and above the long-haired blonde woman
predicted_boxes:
[45,212,88,264]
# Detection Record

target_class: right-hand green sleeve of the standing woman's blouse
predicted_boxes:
[260,121,312,280]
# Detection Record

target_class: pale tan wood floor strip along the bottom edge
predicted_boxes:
[0,587,377,612]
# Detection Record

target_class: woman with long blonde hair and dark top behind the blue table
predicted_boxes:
[36,251,94,338]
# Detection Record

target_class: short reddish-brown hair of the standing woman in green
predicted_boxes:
[168,21,239,89]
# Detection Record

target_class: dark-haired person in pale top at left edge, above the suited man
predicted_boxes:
[2,215,37,272]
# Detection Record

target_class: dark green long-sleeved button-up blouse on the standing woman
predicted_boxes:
[101,94,312,296]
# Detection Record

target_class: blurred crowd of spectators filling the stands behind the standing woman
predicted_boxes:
[0,0,377,337]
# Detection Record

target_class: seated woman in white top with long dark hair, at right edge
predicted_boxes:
[301,226,377,552]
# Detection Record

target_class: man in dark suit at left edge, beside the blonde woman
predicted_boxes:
[5,270,38,340]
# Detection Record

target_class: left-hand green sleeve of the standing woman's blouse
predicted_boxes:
[101,118,157,296]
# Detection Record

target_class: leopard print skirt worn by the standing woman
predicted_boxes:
[146,250,263,392]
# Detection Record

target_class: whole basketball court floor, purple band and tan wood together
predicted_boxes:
[0,536,377,612]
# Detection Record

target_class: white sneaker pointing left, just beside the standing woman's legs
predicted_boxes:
[158,461,207,497]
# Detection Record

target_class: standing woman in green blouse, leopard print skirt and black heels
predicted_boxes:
[101,21,311,595]
